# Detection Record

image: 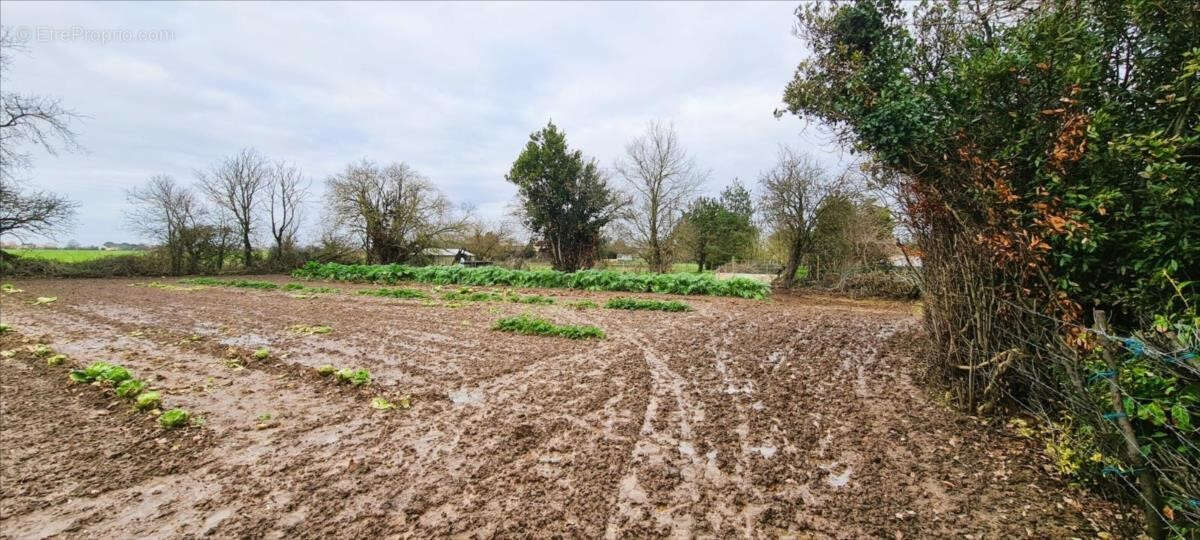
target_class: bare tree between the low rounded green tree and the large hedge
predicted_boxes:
[758,145,852,287]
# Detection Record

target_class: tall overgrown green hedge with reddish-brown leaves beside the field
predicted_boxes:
[785,0,1200,536]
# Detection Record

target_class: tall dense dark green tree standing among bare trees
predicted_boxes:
[505,122,620,271]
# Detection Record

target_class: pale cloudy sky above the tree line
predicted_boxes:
[0,1,845,244]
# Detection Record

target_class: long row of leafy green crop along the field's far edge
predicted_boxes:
[292,262,770,300]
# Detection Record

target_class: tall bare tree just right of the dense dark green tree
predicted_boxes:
[614,122,708,272]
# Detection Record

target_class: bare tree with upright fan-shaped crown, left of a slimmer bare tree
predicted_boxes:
[196,148,271,266]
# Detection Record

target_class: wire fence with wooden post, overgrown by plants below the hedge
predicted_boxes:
[958,295,1200,538]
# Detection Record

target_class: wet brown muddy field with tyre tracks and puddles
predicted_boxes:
[0,277,1135,539]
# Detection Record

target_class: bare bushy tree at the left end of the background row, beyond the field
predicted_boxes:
[125,174,204,274]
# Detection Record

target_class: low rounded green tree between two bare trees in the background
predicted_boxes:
[679,181,758,271]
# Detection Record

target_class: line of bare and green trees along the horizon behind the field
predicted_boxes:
[0,24,892,286]
